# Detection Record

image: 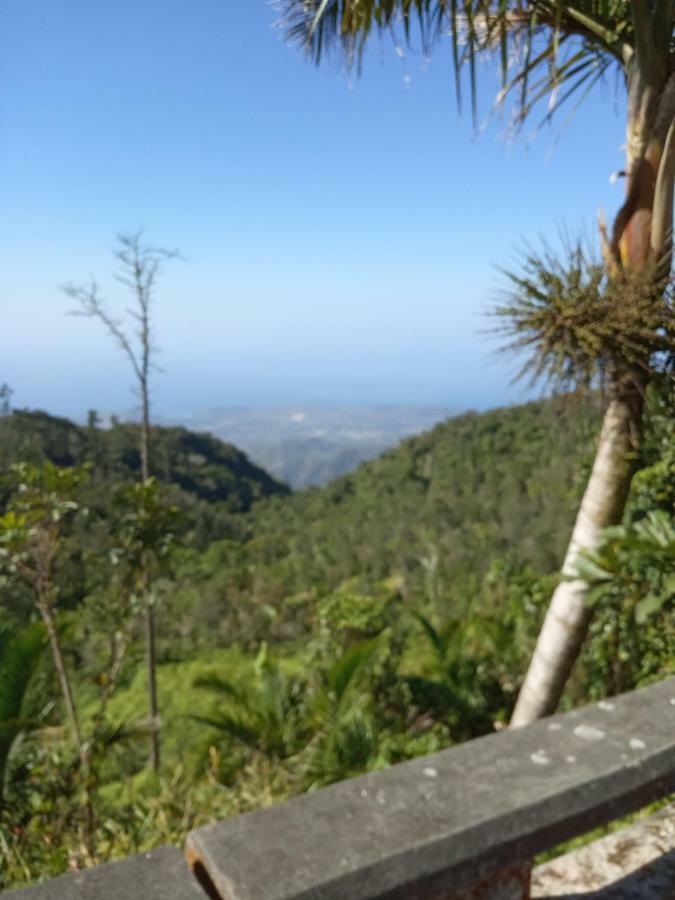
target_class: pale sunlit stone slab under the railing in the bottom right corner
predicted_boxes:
[532,804,675,900]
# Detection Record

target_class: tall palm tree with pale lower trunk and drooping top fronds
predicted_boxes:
[281,0,675,725]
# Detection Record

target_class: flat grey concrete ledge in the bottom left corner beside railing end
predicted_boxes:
[1,847,207,900]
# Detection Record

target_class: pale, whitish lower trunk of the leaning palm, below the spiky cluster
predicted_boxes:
[511,386,644,728]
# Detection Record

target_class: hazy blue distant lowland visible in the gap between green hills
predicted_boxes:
[159,405,451,489]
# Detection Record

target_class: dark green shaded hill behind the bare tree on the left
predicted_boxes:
[0,410,289,512]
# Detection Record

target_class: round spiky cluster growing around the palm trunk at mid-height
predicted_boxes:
[492,241,675,389]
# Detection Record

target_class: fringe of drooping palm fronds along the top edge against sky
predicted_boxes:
[276,0,644,121]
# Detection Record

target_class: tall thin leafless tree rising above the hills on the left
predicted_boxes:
[63,231,179,771]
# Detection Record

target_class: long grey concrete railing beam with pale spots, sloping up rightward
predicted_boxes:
[187,678,675,900]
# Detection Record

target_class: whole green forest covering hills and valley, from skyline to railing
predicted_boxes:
[0,384,675,886]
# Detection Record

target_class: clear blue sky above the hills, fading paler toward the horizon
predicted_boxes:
[0,0,624,415]
